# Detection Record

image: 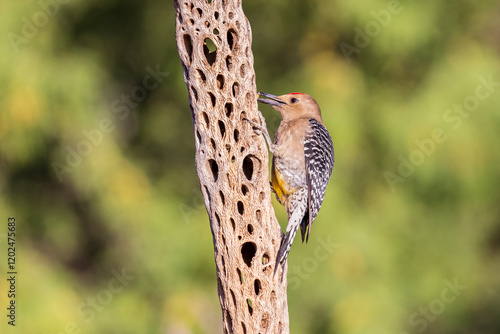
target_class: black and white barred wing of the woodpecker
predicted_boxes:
[300,118,335,241]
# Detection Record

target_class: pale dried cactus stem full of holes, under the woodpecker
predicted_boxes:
[174,0,289,333]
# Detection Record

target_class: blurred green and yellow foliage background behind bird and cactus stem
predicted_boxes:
[0,0,500,334]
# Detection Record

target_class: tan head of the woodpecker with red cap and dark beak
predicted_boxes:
[257,92,322,122]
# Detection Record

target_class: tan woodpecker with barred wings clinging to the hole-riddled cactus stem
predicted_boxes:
[247,93,335,277]
